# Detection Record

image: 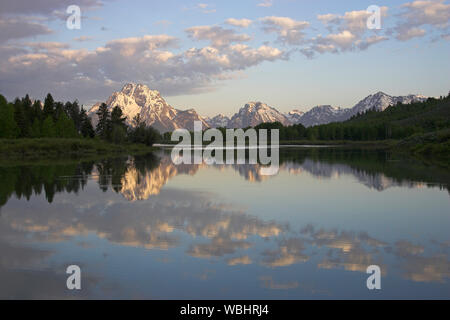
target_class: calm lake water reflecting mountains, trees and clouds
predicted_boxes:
[0,148,450,299]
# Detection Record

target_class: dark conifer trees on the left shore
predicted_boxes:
[0,93,161,145]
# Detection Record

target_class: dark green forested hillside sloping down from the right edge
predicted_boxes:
[255,93,450,141]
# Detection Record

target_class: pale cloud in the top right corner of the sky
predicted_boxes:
[394,0,450,41]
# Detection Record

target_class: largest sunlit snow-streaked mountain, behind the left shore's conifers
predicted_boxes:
[88,83,209,132]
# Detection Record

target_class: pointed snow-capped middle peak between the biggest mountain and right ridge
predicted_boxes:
[228,102,291,128]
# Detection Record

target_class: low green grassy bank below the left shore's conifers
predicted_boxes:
[0,138,156,161]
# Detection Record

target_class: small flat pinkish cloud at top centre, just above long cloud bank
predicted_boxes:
[186,26,250,47]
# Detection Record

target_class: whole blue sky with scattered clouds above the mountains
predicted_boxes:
[0,0,450,116]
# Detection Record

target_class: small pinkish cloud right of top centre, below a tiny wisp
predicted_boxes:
[260,16,309,45]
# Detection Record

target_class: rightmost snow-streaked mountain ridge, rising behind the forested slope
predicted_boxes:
[293,92,427,127]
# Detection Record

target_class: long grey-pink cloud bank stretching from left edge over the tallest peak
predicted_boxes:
[0,35,286,102]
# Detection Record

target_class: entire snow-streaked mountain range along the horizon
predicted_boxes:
[88,83,427,132]
